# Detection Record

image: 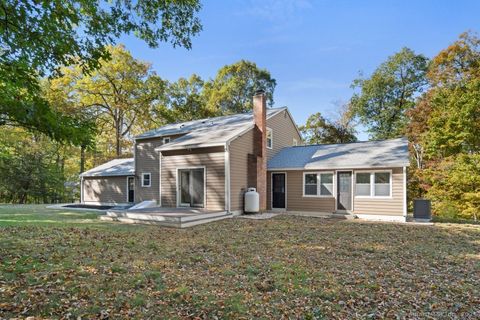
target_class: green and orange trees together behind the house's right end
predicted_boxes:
[349,33,480,220]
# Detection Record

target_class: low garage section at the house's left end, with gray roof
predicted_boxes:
[80,158,135,205]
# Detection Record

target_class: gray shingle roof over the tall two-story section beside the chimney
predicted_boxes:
[146,108,287,151]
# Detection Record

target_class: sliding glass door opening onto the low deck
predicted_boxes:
[178,168,205,208]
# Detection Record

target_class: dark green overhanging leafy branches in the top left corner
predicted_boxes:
[0,0,201,145]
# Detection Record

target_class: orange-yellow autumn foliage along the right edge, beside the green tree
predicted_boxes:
[407,33,480,219]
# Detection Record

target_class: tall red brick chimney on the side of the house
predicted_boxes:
[253,90,267,211]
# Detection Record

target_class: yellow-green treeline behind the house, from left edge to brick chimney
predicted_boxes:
[0,45,276,203]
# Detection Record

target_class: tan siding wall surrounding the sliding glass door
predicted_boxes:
[161,147,225,210]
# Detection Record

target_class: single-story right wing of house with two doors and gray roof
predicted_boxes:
[267,138,409,221]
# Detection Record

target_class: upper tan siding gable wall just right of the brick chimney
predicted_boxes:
[267,111,302,160]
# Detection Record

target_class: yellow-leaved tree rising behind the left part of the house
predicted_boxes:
[49,46,165,157]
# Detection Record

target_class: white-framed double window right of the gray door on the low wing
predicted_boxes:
[355,171,392,197]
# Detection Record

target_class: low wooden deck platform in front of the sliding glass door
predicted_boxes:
[100,211,232,228]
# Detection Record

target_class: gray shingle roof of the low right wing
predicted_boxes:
[268,138,409,170]
